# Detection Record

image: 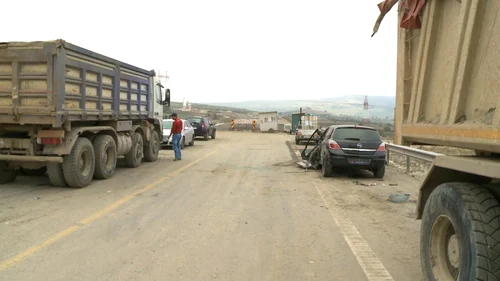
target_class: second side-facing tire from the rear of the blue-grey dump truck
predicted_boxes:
[92,135,118,179]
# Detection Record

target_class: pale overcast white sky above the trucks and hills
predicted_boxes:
[0,0,397,103]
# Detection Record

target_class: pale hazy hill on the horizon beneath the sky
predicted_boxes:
[208,95,396,119]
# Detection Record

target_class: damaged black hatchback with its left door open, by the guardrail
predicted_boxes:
[301,125,387,178]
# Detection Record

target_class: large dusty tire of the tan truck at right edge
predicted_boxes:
[420,183,500,281]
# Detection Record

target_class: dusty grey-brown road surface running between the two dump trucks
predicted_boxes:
[0,131,422,281]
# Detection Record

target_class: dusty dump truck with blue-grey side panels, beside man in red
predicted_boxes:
[0,39,170,188]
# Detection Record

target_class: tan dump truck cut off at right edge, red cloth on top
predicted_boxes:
[374,0,500,280]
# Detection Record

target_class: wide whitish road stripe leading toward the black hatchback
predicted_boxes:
[313,182,394,281]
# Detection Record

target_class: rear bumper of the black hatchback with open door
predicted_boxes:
[328,153,387,170]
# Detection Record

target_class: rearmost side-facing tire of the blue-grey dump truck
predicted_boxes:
[62,137,95,188]
